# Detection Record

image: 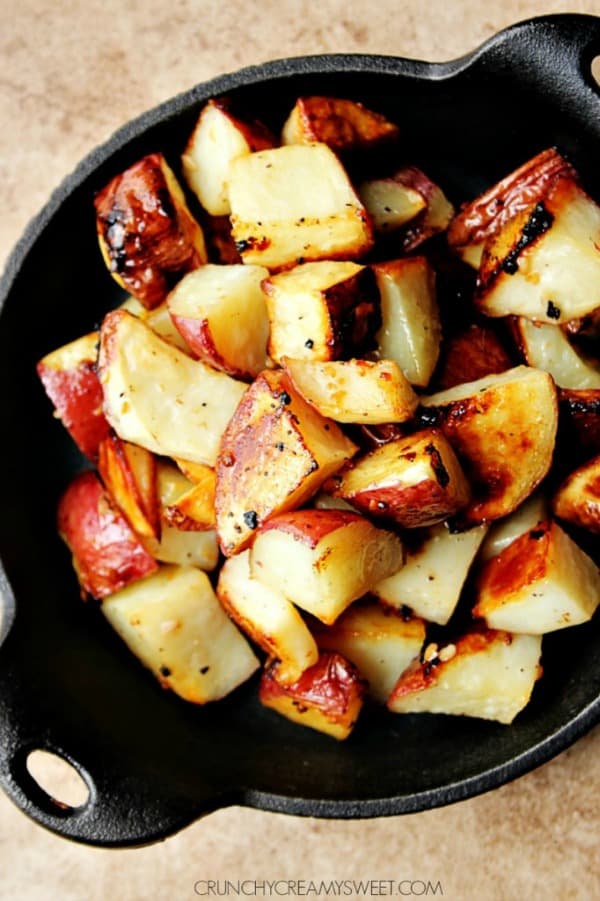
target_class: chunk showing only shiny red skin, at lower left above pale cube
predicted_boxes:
[57,471,158,599]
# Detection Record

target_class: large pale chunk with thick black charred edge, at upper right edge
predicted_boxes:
[475,178,600,325]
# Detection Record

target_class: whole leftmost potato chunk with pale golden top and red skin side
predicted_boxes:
[37,332,110,461]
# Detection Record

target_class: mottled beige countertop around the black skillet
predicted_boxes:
[0,0,600,901]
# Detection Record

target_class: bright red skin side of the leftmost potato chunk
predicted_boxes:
[37,360,110,462]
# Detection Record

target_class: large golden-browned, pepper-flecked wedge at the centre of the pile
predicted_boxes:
[215,370,356,556]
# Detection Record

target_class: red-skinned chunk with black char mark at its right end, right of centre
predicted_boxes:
[325,429,471,529]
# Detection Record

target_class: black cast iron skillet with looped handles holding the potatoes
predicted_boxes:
[0,15,600,845]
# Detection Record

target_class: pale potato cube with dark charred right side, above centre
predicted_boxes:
[263,260,379,363]
